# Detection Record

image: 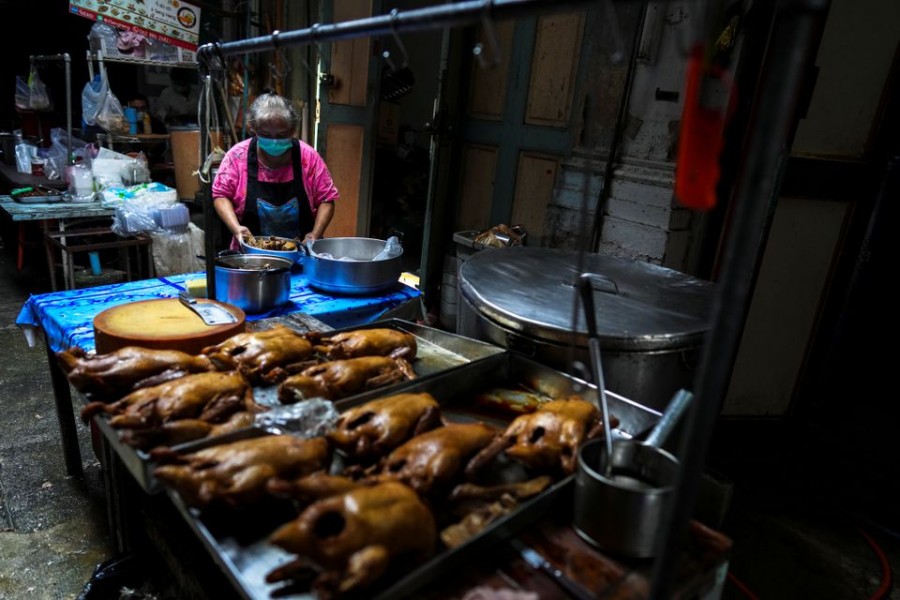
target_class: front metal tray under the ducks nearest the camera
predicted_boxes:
[156,353,660,600]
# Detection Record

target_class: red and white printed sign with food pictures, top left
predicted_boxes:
[69,0,200,50]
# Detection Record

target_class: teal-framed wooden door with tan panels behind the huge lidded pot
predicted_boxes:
[454,13,584,245]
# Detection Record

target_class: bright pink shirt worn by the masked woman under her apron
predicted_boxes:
[212,138,338,221]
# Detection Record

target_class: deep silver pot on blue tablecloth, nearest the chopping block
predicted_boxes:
[216,254,294,313]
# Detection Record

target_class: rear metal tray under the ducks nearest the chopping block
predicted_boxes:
[95,319,506,494]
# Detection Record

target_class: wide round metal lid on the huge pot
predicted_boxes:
[459,246,715,351]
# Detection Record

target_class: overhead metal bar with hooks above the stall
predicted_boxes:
[197,0,596,68]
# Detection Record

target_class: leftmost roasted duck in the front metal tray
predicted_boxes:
[153,435,330,508]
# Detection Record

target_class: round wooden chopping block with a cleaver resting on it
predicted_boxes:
[94,298,245,354]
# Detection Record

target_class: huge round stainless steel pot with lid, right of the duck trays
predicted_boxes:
[458,246,715,409]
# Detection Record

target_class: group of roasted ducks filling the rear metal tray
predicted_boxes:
[57,325,417,449]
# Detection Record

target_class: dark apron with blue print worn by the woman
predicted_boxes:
[242,138,314,239]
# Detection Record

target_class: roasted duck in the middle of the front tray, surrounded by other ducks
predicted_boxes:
[375,423,498,494]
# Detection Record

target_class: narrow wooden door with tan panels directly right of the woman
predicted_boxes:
[315,0,380,237]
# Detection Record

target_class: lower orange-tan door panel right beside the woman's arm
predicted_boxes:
[326,123,366,237]
